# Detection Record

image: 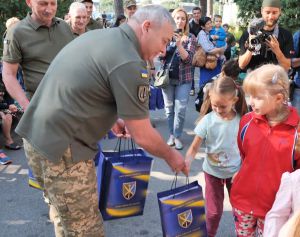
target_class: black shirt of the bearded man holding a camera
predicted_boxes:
[239,27,294,71]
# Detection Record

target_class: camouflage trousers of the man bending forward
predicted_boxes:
[23,139,104,237]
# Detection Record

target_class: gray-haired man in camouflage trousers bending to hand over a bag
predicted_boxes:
[16,5,186,237]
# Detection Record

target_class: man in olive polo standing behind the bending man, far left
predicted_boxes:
[3,0,74,236]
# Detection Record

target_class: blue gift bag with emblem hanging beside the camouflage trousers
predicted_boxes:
[97,139,152,220]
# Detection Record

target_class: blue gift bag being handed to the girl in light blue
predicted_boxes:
[157,181,207,237]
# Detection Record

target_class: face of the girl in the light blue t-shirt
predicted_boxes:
[209,92,238,119]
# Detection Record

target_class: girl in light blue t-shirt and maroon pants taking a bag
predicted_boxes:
[186,75,247,237]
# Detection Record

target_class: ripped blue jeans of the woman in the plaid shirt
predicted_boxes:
[162,82,192,138]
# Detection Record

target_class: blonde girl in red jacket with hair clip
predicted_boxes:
[230,64,300,236]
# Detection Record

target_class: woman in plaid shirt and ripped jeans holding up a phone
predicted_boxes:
[162,8,197,150]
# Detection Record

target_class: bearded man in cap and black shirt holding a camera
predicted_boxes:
[239,0,293,71]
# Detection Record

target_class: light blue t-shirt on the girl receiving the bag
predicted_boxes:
[194,111,241,179]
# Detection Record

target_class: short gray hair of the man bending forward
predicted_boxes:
[130,4,176,28]
